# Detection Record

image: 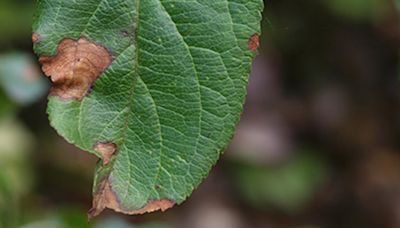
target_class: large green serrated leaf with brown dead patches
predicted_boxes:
[33,0,263,216]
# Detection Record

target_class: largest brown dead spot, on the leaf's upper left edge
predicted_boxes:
[39,38,112,100]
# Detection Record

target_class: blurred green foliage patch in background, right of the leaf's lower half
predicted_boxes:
[233,152,327,213]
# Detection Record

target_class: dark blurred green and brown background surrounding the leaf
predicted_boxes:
[0,0,400,228]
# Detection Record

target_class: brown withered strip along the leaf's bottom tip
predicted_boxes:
[88,178,175,219]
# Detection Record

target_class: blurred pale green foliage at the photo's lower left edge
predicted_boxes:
[0,118,33,227]
